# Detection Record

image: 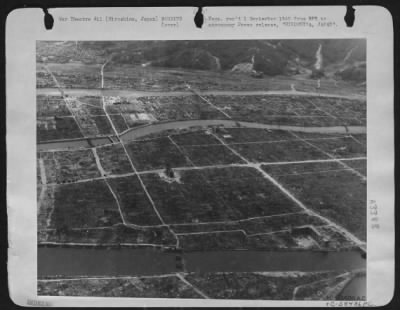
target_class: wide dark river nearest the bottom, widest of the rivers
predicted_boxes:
[38,247,366,277]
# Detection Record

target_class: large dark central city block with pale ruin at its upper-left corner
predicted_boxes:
[142,168,299,223]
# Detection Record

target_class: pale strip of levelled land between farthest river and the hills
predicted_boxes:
[37,59,365,95]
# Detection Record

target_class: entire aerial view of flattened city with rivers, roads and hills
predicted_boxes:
[36,39,367,300]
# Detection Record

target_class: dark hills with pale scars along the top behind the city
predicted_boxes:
[37,39,366,82]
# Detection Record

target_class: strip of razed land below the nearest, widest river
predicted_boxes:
[38,271,353,300]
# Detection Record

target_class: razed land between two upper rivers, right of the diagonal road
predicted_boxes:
[206,94,366,126]
